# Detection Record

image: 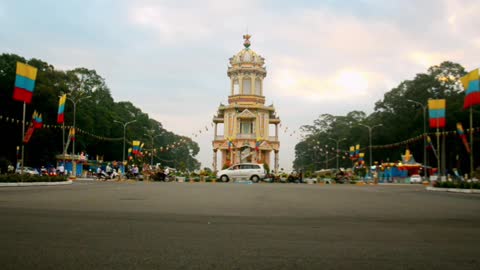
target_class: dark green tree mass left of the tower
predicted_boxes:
[0,54,200,170]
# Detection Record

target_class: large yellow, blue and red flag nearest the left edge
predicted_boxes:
[13,62,37,104]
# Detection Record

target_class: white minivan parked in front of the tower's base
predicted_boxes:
[217,163,266,182]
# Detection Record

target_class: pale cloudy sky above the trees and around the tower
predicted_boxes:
[0,0,480,169]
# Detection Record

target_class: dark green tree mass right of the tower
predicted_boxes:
[294,61,472,174]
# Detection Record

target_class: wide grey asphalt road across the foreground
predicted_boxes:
[0,182,480,270]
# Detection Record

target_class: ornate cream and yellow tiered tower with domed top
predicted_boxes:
[212,34,280,172]
